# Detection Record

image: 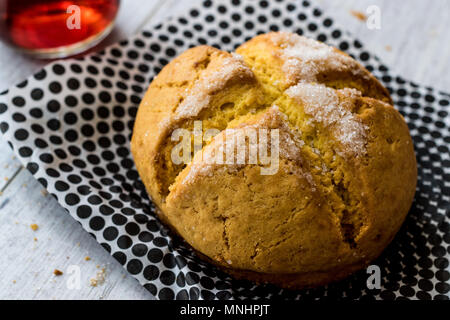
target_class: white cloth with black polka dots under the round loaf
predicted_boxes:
[0,0,450,300]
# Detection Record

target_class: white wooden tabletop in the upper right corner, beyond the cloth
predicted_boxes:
[317,0,450,92]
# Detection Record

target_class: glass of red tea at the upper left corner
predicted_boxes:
[0,0,120,58]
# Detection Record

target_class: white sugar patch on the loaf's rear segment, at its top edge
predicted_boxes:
[272,32,355,82]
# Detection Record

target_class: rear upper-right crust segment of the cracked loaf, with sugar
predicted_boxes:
[236,32,392,104]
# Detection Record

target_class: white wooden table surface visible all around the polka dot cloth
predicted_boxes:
[0,0,450,299]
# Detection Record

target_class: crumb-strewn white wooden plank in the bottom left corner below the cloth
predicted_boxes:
[0,170,151,299]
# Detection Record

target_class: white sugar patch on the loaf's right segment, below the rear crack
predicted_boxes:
[286,83,367,156]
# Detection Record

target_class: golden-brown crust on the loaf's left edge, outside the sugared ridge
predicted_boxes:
[131,46,255,210]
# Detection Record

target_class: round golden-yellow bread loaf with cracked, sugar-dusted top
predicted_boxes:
[131,32,417,288]
